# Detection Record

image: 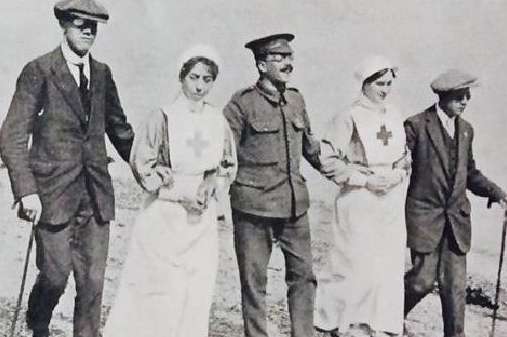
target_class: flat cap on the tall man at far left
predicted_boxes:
[54,0,109,23]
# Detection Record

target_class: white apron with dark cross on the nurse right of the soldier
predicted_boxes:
[315,101,407,333]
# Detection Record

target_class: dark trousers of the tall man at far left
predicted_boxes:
[26,193,109,337]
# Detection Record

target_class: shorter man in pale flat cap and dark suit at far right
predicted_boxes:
[405,69,506,337]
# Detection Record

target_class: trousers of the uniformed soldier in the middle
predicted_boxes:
[232,210,317,337]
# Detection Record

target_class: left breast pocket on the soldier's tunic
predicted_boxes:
[246,119,284,164]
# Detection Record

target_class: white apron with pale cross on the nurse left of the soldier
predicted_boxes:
[103,98,230,337]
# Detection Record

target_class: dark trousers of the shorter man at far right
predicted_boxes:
[405,224,466,337]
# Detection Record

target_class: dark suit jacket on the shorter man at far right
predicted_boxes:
[405,106,504,253]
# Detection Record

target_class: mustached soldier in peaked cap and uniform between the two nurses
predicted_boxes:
[224,34,321,337]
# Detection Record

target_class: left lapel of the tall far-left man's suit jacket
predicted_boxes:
[51,47,86,123]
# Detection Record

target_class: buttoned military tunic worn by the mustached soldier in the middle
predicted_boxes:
[224,82,320,218]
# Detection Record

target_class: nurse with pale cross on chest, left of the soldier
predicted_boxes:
[103,46,236,337]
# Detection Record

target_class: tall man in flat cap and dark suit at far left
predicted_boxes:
[0,0,134,337]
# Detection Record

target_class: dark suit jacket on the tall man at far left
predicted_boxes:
[0,47,134,224]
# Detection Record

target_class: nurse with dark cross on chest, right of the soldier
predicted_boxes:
[315,56,410,336]
